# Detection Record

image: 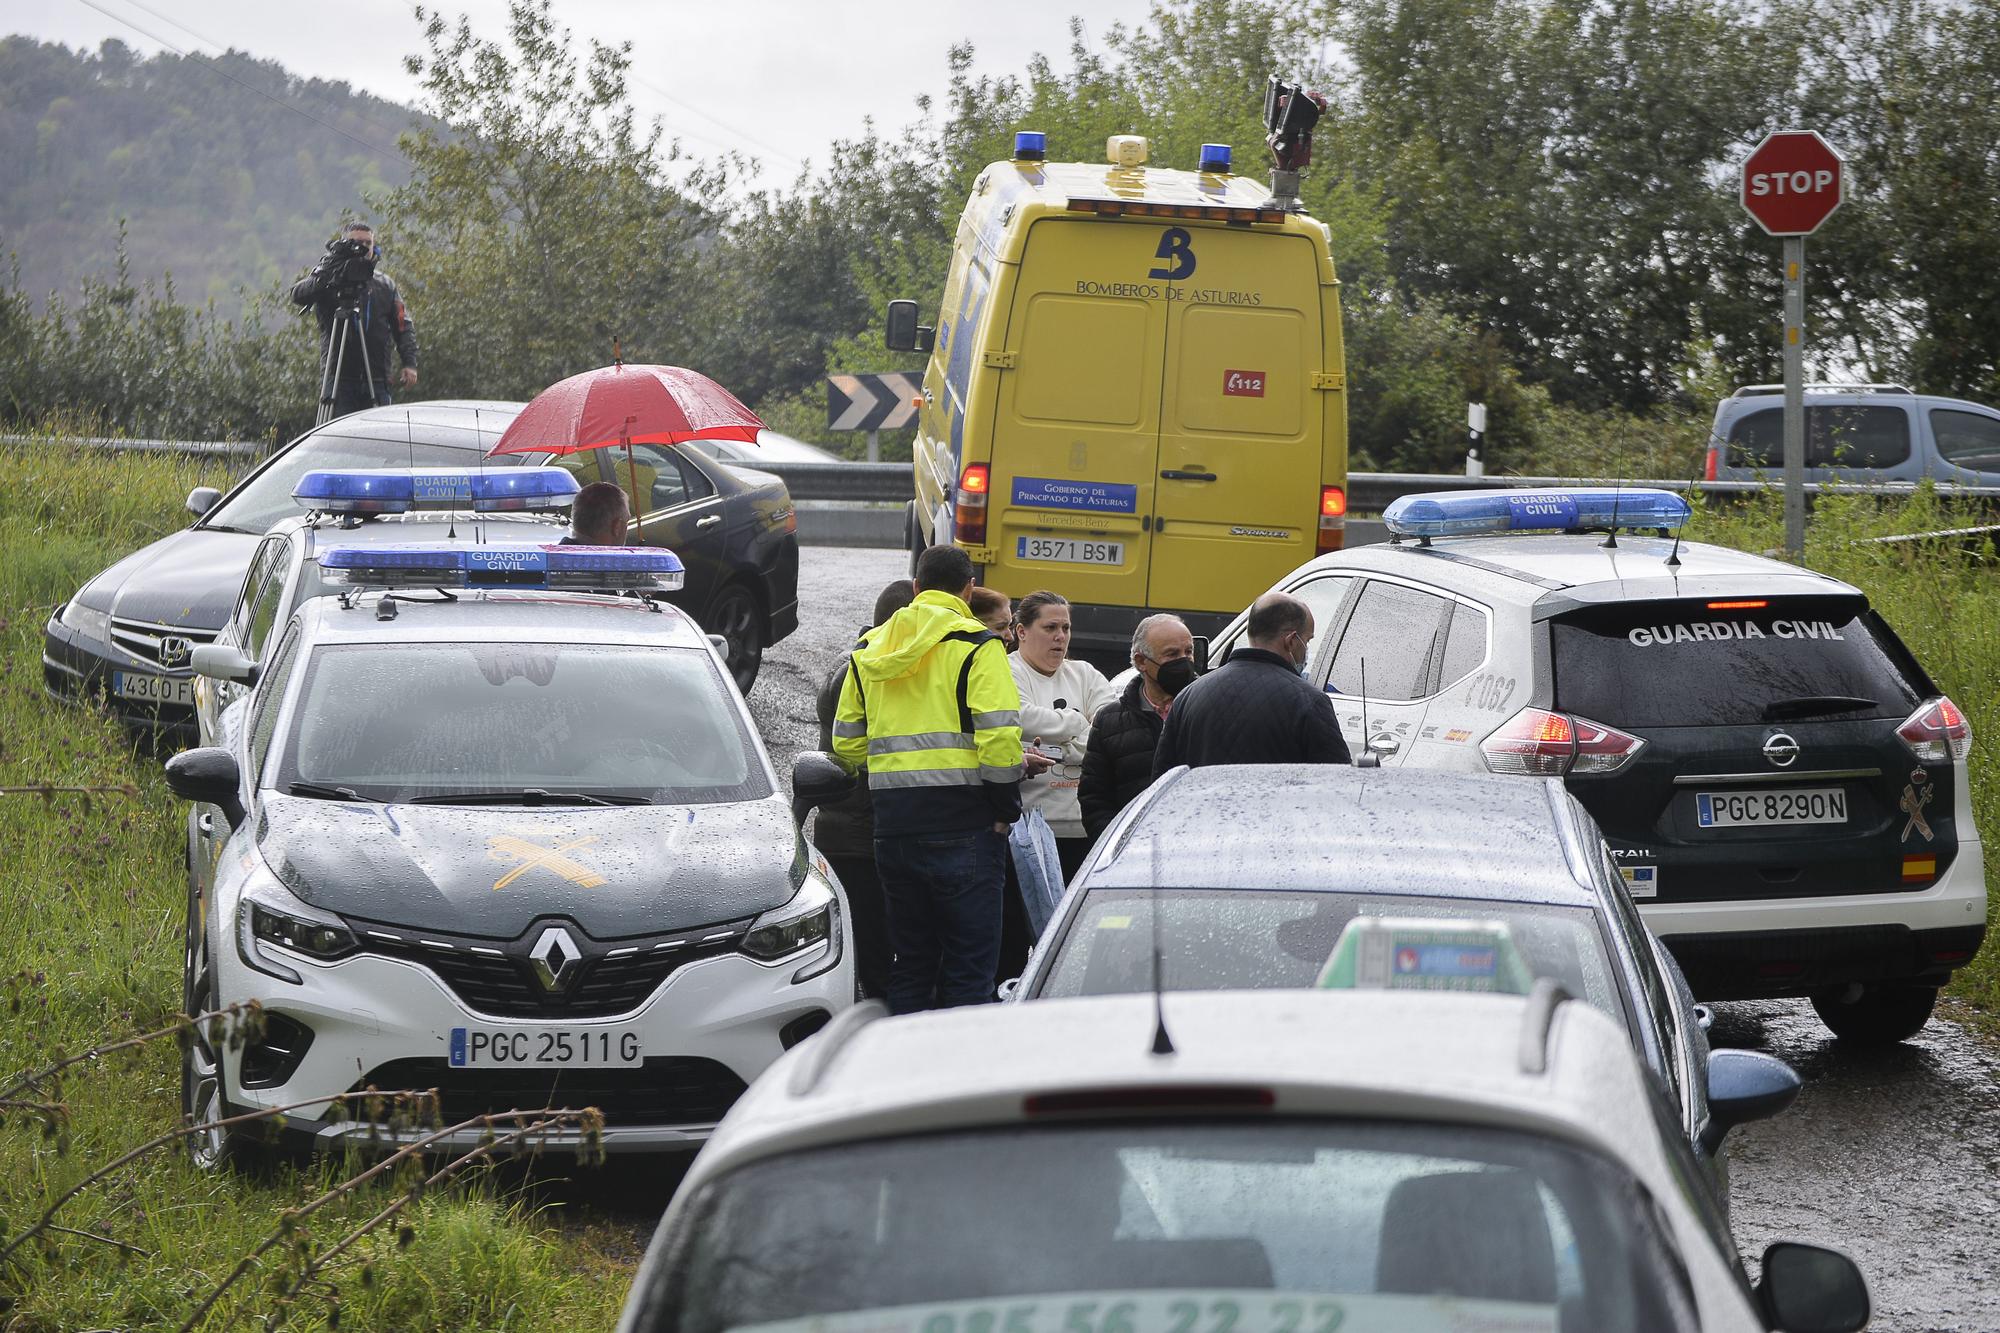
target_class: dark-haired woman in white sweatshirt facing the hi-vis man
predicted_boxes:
[1010,592,1116,879]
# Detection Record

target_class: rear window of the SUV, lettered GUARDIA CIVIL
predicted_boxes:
[1552,596,1920,729]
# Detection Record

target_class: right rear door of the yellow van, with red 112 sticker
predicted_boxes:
[1132,226,1326,610]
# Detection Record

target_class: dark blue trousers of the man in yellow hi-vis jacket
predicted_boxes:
[876,829,1006,1013]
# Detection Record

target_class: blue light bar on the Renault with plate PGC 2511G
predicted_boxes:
[320,542,686,592]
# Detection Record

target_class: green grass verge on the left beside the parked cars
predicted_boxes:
[0,442,636,1333]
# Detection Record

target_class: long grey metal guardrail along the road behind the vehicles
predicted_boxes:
[15,434,2000,514]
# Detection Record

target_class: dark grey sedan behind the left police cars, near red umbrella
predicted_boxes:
[42,402,798,743]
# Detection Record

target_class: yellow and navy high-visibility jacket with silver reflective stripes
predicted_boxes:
[834,592,1022,837]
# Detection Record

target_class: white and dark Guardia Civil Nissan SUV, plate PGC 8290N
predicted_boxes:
[1210,486,1986,1043]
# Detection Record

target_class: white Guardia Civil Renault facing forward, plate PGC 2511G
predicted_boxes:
[166,490,854,1165]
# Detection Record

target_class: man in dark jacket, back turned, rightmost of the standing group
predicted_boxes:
[1152,592,1352,777]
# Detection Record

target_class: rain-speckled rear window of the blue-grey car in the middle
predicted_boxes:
[1038,889,1630,1031]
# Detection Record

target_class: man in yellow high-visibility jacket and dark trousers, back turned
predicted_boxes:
[834,546,1022,1013]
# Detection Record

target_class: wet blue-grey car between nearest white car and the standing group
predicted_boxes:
[1016,765,1798,1201]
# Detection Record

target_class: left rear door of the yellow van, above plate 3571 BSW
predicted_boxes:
[986,218,1168,606]
